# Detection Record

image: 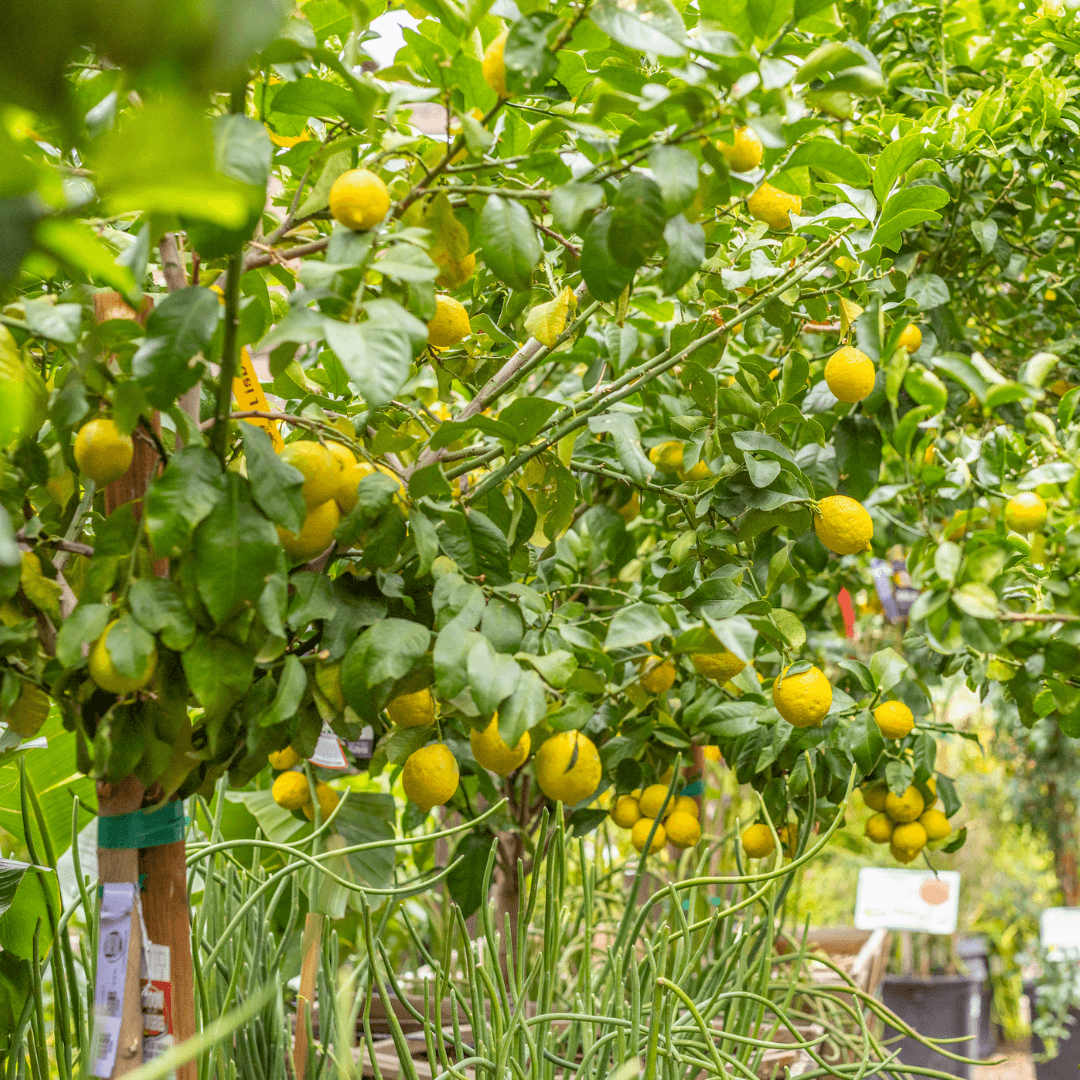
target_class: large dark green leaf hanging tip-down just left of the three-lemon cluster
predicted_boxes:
[192,472,281,625]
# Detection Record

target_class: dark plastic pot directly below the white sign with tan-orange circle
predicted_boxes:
[881,975,984,1080]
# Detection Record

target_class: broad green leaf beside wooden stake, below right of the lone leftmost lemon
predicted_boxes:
[145,446,226,558]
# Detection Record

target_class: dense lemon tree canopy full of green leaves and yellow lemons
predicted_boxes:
[16,0,1080,946]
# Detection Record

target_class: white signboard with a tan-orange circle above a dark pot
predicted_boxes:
[855,866,960,934]
